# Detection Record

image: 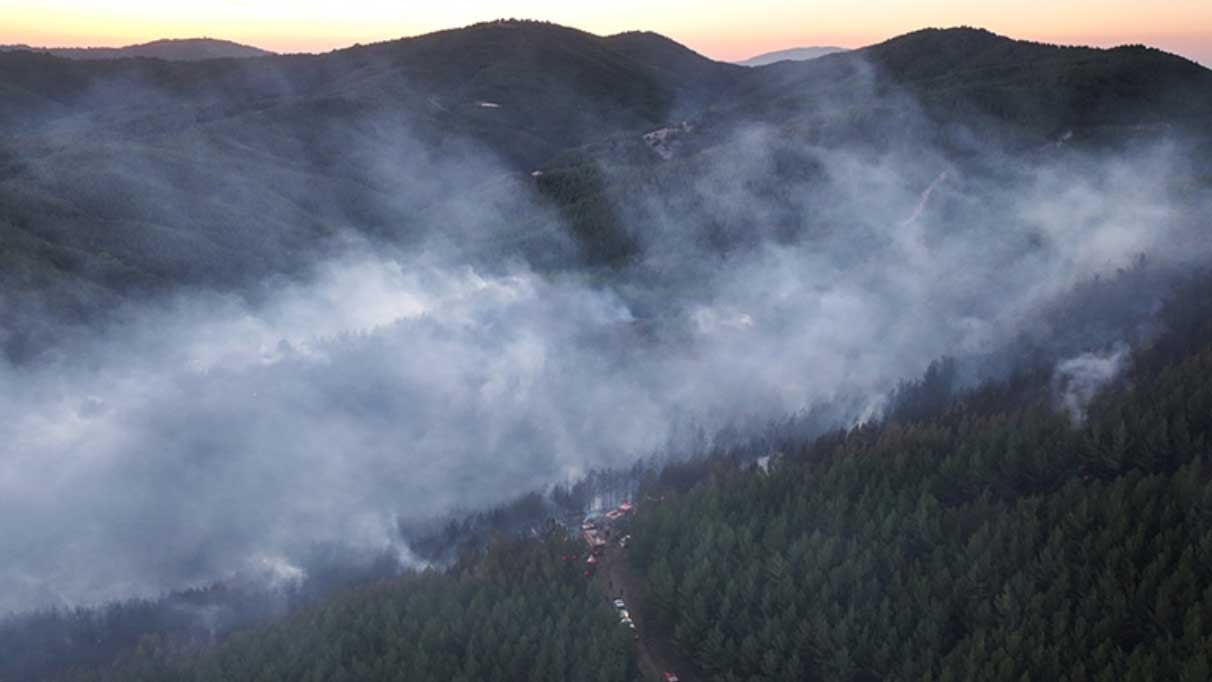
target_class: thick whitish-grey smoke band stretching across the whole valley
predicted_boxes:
[0,56,1207,611]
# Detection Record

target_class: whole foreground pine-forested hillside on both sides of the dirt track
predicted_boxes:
[21,271,1212,682]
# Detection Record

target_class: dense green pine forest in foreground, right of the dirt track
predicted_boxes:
[630,334,1212,681]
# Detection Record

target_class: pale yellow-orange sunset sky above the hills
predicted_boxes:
[0,0,1212,65]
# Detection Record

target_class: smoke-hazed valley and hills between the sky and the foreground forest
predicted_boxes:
[0,18,1212,625]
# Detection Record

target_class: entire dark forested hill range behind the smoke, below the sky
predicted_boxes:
[0,22,1212,356]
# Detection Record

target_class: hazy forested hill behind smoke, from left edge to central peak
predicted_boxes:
[0,22,737,360]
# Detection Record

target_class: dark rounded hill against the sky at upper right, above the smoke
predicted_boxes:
[719,27,1212,148]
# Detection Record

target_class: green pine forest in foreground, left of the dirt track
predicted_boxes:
[54,537,636,682]
